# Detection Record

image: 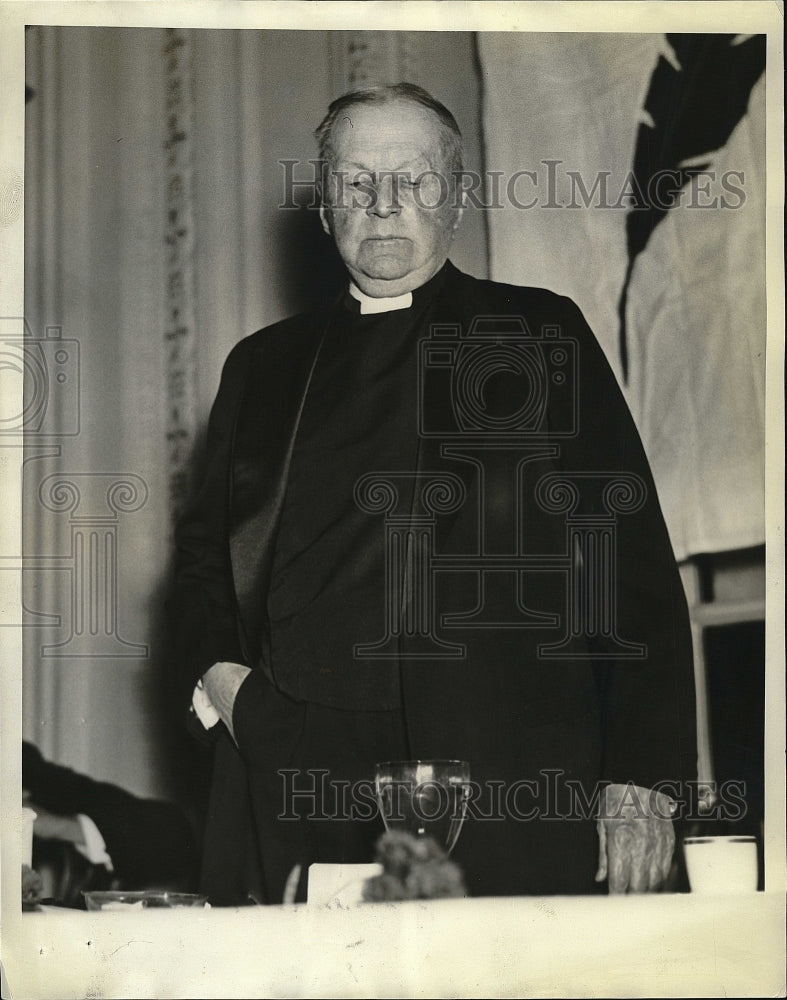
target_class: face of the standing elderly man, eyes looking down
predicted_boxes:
[320,101,462,298]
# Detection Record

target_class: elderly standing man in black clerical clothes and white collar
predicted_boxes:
[174,84,696,903]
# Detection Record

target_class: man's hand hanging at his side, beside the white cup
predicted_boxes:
[596,784,675,894]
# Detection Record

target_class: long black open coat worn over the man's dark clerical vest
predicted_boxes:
[173,263,696,902]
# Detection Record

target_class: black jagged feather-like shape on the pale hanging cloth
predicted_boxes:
[618,34,766,380]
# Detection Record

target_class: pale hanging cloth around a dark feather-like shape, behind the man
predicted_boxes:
[479,33,766,558]
